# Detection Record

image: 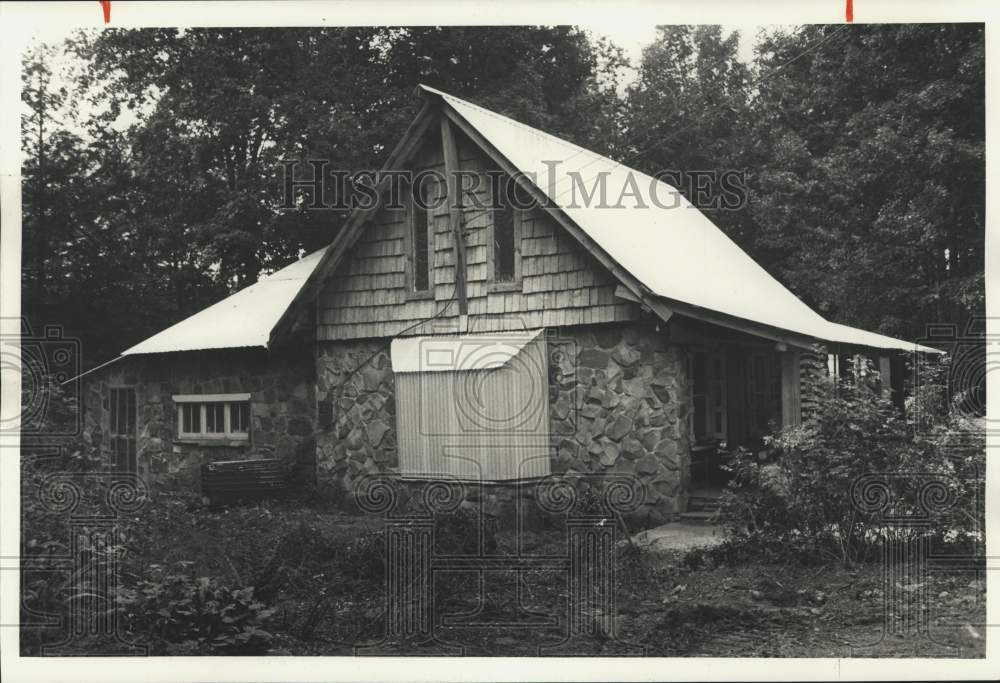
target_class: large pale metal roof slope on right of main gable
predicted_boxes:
[420,86,938,353]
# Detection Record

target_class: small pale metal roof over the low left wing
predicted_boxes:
[122,247,328,356]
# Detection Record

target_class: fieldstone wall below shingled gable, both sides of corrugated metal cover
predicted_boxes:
[316,323,690,525]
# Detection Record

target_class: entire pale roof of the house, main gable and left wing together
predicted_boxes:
[122,85,940,356]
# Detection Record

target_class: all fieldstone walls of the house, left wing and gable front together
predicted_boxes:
[84,323,690,526]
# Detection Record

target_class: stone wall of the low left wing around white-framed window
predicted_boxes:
[83,346,316,488]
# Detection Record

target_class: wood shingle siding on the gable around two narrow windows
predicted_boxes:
[317,136,639,340]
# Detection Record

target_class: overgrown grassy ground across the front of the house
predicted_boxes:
[25,496,986,657]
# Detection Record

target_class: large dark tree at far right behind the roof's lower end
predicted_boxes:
[749,24,985,338]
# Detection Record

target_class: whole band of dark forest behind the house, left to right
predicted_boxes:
[22,24,985,367]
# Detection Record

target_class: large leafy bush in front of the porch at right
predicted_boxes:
[722,364,985,563]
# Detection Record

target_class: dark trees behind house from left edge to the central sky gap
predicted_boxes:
[22,26,624,366]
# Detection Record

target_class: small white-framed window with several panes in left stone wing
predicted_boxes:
[172,394,250,442]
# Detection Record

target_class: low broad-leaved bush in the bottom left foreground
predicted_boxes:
[119,563,272,655]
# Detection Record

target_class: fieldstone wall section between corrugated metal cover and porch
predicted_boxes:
[549,323,690,525]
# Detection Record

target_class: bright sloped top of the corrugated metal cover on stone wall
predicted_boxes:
[390,330,542,373]
